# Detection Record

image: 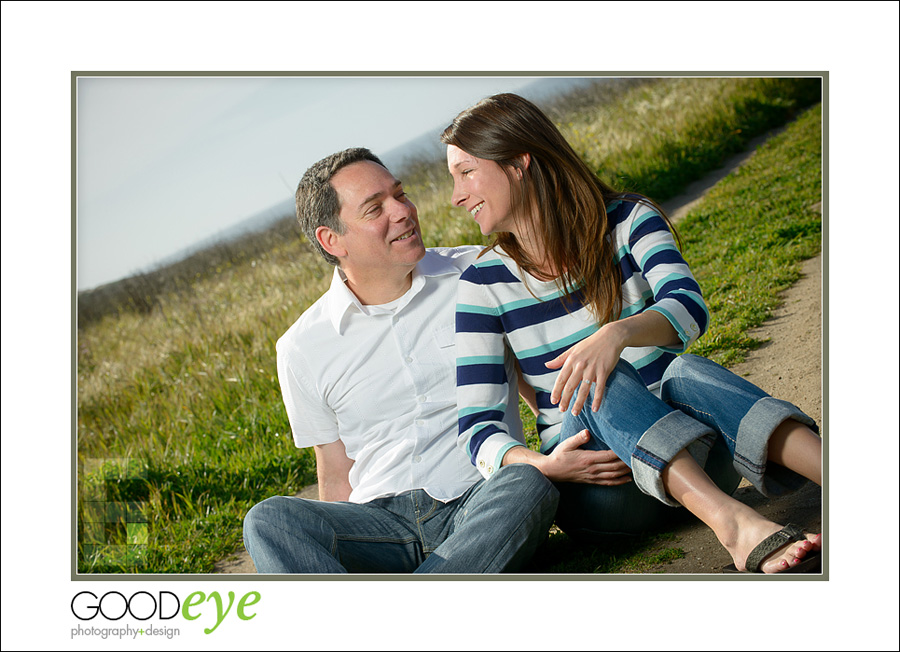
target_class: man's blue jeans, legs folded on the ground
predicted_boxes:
[244,464,559,573]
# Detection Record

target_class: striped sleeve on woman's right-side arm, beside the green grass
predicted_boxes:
[611,203,709,353]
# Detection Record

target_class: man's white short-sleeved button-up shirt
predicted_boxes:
[276,247,522,503]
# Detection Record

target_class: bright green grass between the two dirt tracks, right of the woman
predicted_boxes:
[678,107,822,366]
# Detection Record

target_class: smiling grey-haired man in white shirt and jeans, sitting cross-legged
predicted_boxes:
[244,148,558,573]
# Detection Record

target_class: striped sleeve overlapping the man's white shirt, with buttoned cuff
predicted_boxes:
[456,261,524,478]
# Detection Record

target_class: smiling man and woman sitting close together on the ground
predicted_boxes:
[244,94,822,573]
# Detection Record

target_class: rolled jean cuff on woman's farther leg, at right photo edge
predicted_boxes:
[734,396,819,496]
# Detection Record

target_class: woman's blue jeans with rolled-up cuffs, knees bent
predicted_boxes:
[556,355,817,539]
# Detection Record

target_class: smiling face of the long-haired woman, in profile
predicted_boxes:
[447,145,521,235]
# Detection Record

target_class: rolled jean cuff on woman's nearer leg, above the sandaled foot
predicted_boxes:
[631,411,716,507]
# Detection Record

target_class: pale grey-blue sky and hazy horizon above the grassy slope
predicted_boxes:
[76,75,592,290]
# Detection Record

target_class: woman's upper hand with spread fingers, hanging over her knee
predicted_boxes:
[546,322,626,415]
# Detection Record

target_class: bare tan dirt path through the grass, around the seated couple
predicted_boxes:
[215,127,822,573]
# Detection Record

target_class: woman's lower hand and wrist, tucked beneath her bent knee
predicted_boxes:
[503,430,632,486]
